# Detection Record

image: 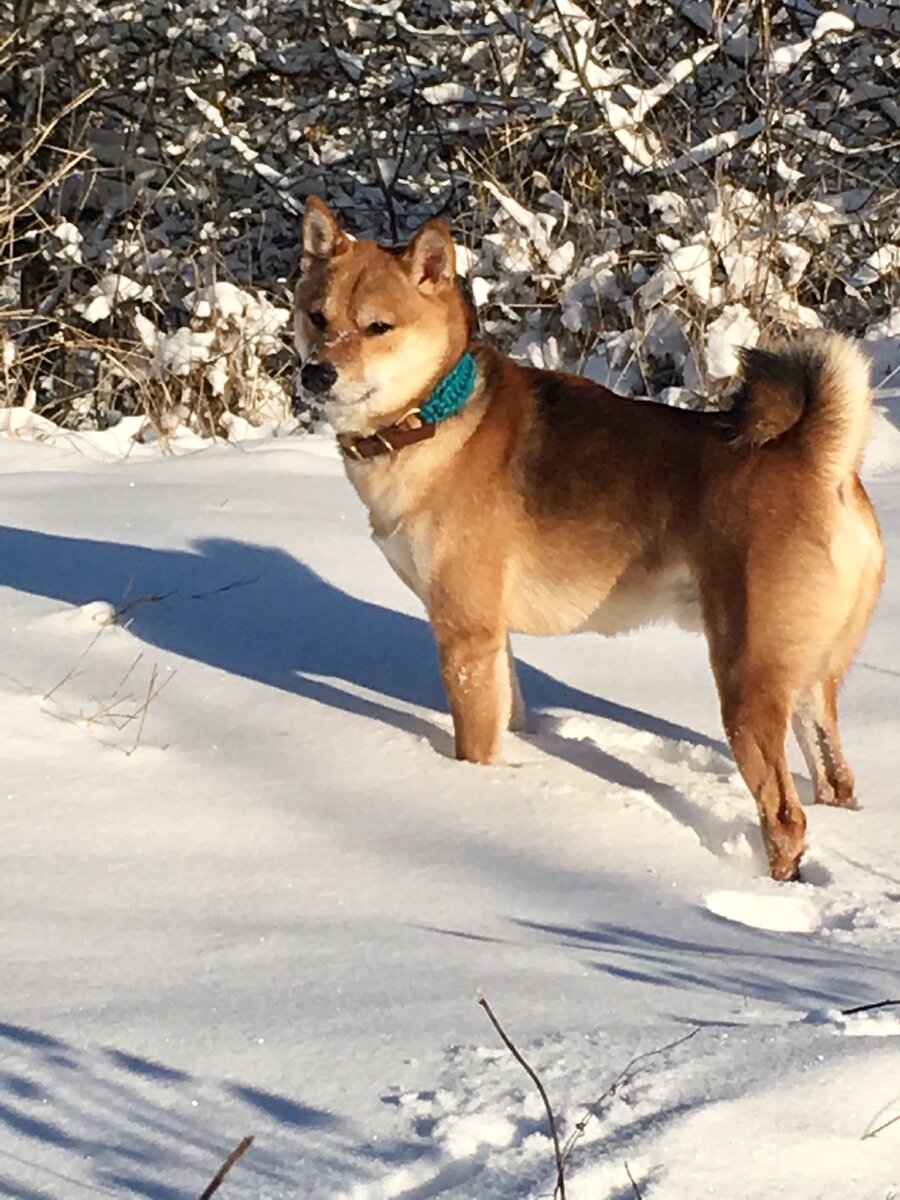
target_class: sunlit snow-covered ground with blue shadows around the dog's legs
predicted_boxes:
[0,376,900,1200]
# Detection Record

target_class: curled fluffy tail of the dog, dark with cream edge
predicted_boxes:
[730,334,871,485]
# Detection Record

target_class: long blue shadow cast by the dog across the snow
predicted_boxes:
[0,526,727,752]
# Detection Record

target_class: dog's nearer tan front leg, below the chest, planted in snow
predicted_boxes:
[436,629,512,762]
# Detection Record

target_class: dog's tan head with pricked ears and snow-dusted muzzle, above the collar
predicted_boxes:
[294,197,469,433]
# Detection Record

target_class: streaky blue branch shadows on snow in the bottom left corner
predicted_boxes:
[0,1022,430,1200]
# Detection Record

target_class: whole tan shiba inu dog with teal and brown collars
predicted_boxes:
[295,198,883,880]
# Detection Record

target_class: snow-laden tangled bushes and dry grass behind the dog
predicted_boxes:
[0,0,900,433]
